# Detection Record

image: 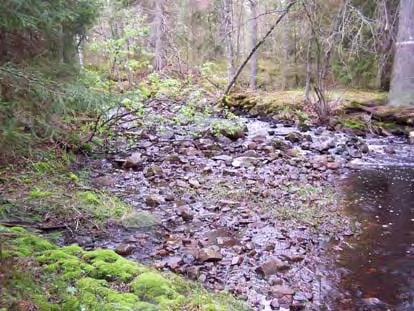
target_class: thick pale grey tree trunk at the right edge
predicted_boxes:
[389,0,414,106]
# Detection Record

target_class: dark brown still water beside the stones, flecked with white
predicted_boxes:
[338,167,414,310]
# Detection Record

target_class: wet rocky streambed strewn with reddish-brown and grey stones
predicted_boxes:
[66,100,411,310]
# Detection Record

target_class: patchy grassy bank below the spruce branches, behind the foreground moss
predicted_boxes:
[0,153,157,230]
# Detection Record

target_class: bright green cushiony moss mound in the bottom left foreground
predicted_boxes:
[0,226,246,311]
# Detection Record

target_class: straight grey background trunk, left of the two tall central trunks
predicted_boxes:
[154,0,165,71]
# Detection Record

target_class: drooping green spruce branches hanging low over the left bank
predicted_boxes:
[0,64,113,159]
